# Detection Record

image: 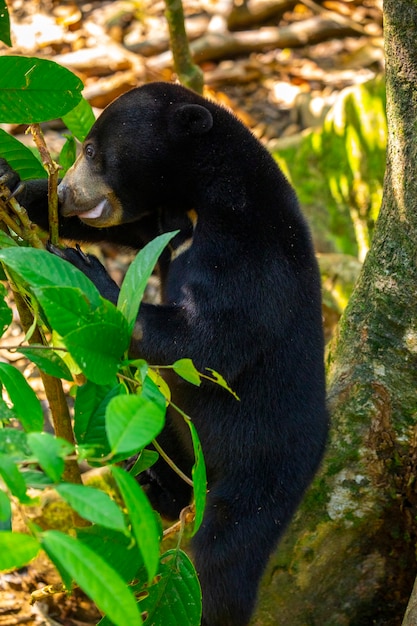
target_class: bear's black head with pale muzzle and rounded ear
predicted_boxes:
[58,83,214,228]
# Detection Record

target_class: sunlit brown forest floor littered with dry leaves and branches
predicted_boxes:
[0,0,383,626]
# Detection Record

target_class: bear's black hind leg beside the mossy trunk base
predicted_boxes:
[192,492,281,626]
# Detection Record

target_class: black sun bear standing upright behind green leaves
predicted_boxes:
[0,83,328,626]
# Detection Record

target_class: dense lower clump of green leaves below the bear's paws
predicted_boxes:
[0,227,205,625]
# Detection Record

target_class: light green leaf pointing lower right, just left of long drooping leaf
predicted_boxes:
[55,483,127,533]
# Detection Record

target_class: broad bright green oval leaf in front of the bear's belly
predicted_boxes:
[106,395,166,454]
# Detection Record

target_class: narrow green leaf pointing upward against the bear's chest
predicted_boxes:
[117,231,178,334]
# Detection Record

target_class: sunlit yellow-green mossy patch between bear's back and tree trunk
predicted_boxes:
[276,78,387,260]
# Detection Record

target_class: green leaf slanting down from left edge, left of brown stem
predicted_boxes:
[0,363,43,432]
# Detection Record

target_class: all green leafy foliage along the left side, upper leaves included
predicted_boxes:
[0,12,214,626]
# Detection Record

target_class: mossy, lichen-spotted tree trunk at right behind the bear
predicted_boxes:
[250,0,417,626]
